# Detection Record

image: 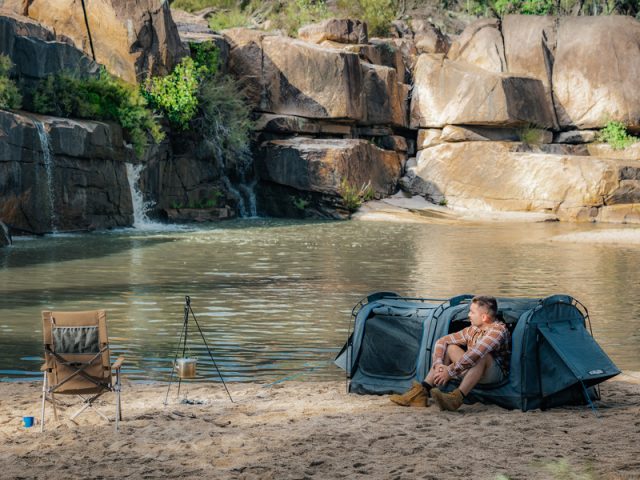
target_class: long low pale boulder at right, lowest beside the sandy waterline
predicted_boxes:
[413,142,640,220]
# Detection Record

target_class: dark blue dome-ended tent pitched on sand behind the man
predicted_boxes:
[336,292,620,411]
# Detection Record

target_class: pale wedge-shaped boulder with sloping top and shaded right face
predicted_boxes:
[410,54,553,128]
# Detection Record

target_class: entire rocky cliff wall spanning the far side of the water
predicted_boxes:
[0,0,640,231]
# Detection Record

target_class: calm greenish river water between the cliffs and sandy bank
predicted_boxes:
[0,219,640,382]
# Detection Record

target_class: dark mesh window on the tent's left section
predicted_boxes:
[359,315,423,377]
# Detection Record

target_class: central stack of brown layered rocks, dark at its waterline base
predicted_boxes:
[223,20,414,217]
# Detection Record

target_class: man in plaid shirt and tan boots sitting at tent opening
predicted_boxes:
[390,296,511,410]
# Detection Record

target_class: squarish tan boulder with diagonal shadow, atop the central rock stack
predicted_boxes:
[262,36,364,120]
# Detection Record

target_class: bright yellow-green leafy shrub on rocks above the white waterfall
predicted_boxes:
[142,57,201,130]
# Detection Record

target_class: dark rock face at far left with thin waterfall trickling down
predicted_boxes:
[0,111,133,233]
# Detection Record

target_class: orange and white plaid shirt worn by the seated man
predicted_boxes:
[433,322,511,377]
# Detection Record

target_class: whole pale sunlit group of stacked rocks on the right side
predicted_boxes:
[401,16,640,222]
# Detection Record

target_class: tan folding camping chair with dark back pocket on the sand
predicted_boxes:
[40,310,124,432]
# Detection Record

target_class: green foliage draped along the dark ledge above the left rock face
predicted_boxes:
[33,70,164,156]
